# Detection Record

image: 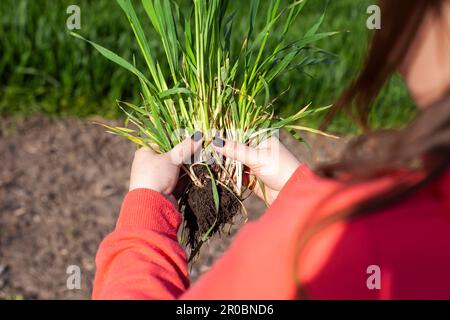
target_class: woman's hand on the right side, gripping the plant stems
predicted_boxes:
[213,137,300,204]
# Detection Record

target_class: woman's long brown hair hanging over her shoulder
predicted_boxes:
[293,0,450,298]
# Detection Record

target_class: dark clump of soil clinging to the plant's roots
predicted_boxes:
[183,166,241,254]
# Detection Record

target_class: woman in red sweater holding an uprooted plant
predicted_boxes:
[93,0,450,299]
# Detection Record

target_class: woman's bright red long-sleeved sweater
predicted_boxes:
[93,165,450,299]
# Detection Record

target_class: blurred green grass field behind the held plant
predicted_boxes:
[0,0,414,132]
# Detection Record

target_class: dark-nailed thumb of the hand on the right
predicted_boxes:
[213,137,261,169]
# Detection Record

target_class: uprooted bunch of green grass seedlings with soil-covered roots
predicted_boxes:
[73,0,334,258]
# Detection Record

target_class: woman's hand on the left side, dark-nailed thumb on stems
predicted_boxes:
[130,132,203,200]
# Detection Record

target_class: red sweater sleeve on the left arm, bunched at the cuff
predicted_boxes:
[92,189,189,299]
